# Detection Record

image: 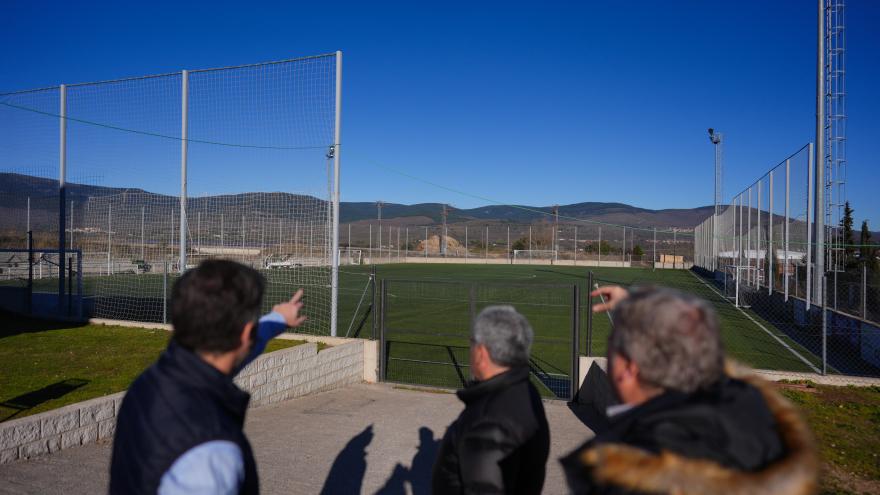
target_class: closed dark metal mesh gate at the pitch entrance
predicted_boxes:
[379,279,580,400]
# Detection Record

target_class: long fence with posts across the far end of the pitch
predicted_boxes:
[340,223,694,268]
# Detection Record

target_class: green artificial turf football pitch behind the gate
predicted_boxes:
[12,263,820,396]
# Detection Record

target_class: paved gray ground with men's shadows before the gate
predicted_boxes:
[0,384,591,494]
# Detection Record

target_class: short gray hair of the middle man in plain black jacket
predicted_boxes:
[471,306,534,366]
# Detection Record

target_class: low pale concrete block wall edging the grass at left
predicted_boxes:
[0,339,366,464]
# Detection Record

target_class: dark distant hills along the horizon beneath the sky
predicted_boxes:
[0,173,712,229]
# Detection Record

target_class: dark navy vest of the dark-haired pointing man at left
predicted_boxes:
[110,341,259,494]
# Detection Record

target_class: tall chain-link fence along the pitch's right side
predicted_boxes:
[694,145,880,376]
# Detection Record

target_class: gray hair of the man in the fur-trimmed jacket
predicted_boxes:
[608,287,724,393]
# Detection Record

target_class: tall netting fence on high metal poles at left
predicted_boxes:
[0,53,341,333]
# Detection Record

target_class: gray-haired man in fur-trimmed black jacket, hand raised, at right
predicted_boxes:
[562,287,817,495]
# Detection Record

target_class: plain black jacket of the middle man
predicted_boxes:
[432,367,550,494]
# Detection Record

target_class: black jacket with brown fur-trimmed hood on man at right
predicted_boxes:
[561,366,816,495]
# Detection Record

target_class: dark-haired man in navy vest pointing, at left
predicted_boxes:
[110,260,305,494]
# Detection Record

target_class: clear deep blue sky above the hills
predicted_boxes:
[0,0,880,228]
